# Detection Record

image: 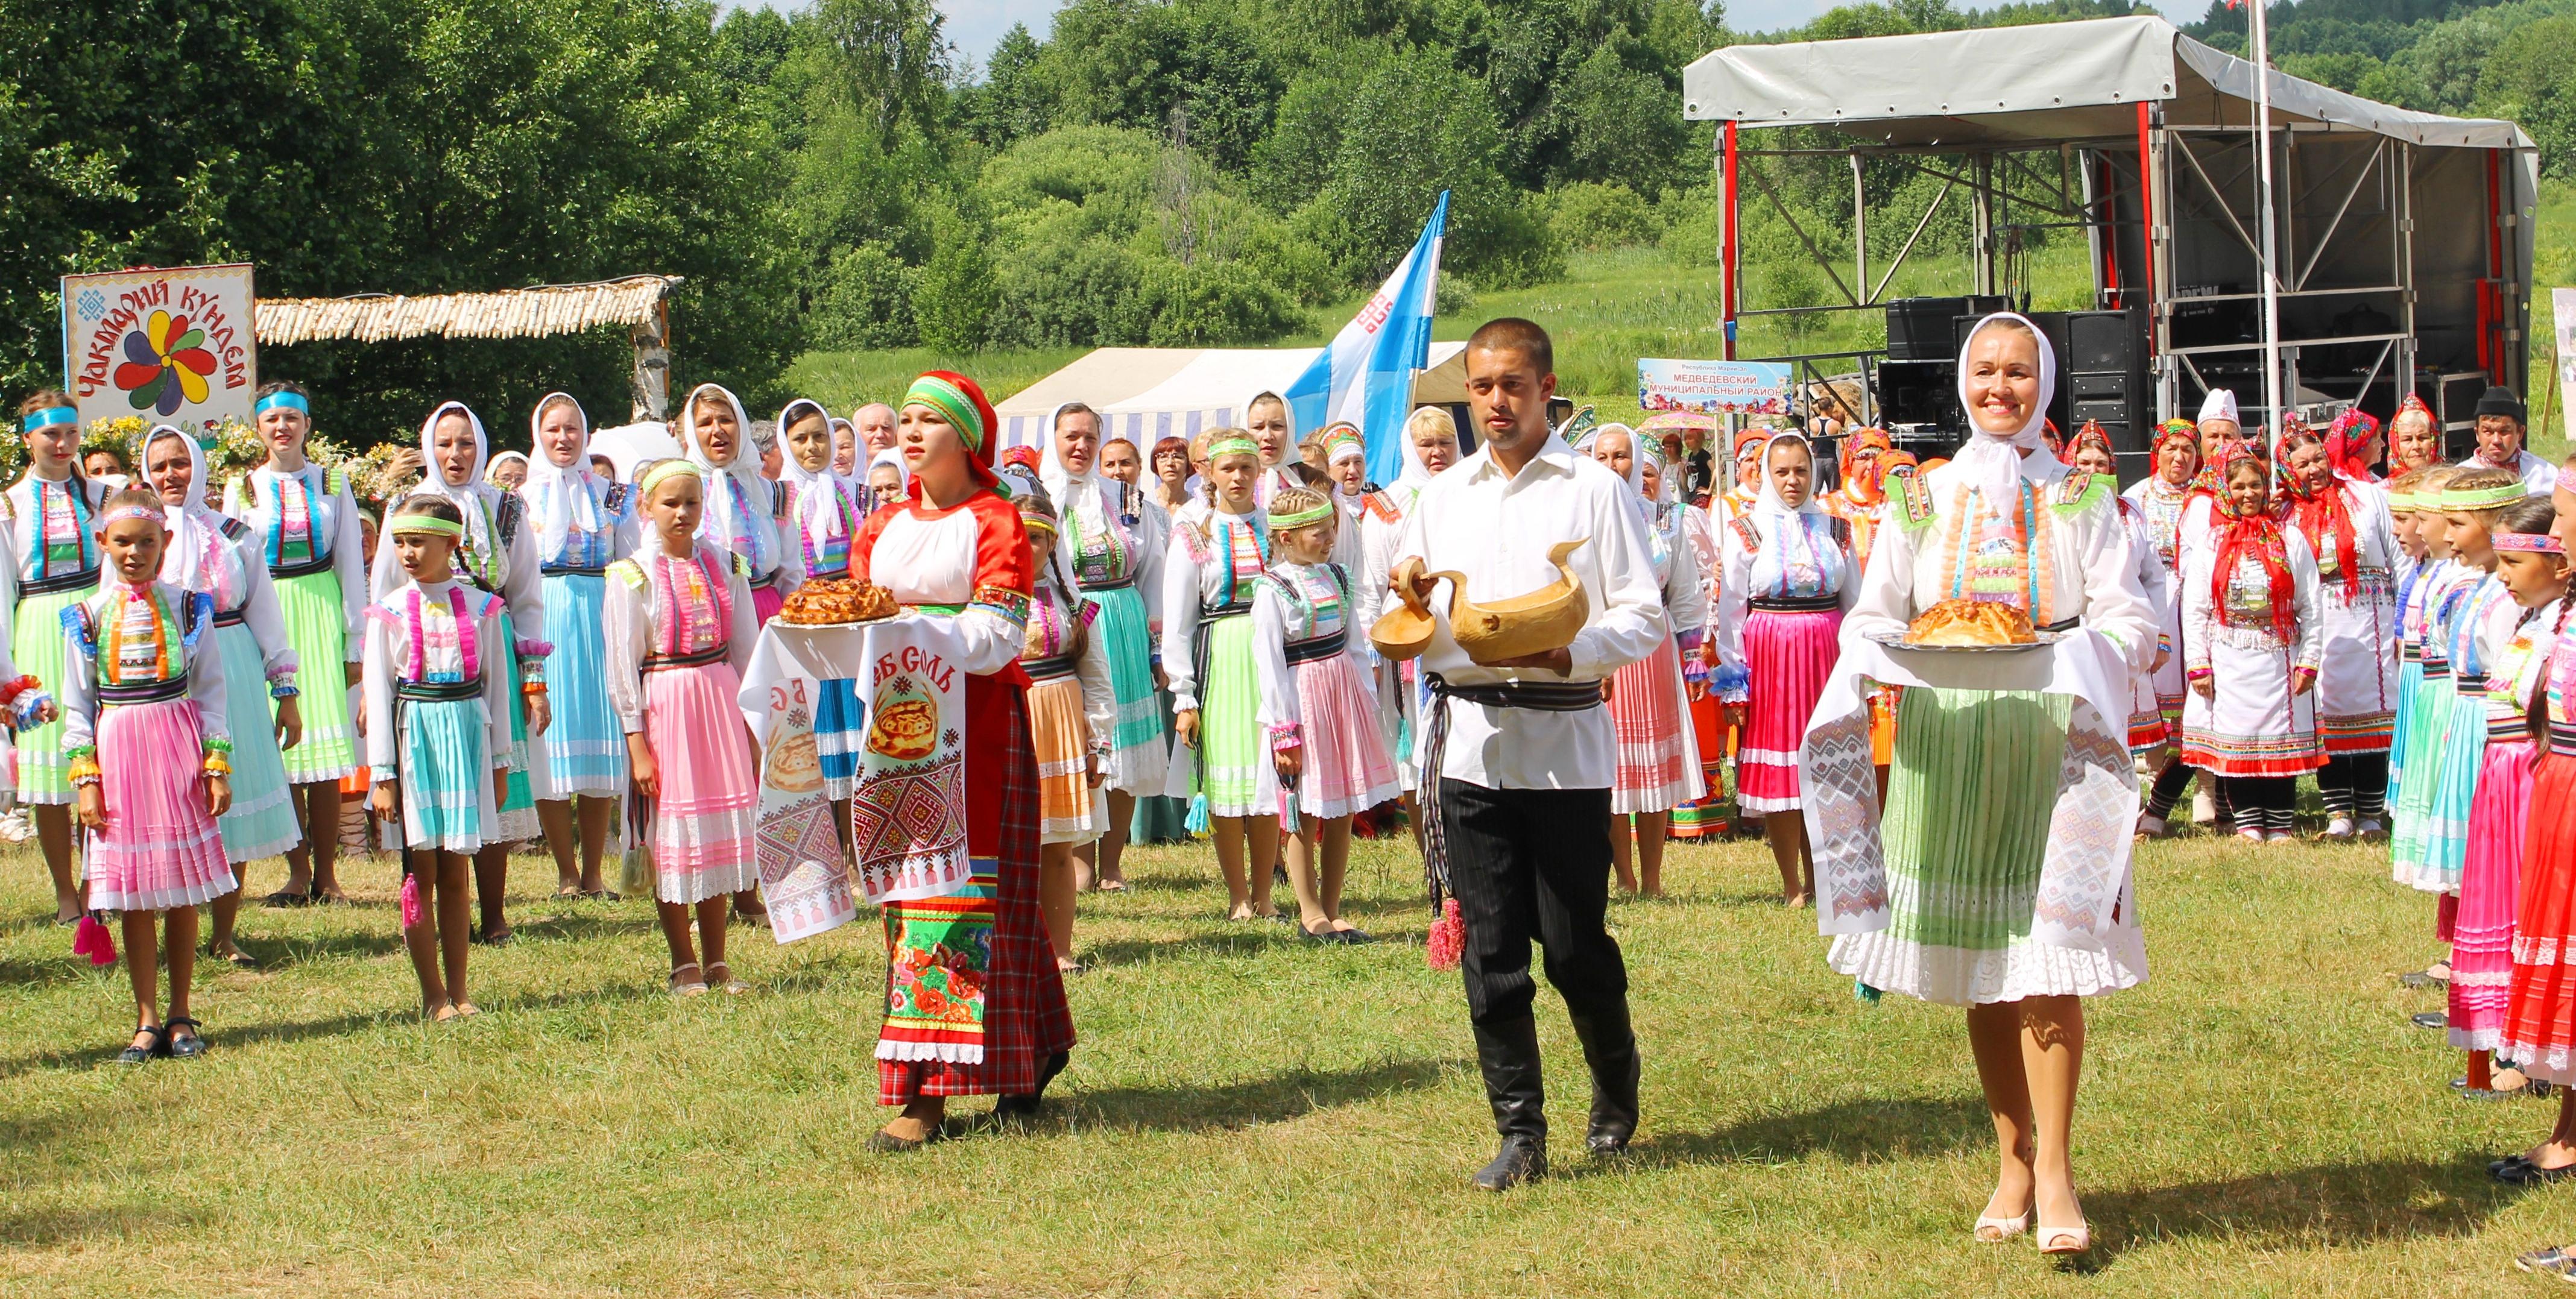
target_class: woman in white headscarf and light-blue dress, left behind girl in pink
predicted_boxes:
[520,392,636,897]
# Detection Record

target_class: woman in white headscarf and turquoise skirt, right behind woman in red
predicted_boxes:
[1038,402,1169,892]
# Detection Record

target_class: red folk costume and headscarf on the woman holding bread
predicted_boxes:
[850,371,1074,1106]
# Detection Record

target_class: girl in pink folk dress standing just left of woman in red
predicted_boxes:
[603,459,760,998]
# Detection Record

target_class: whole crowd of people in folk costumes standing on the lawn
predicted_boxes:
[25,315,2576,1273]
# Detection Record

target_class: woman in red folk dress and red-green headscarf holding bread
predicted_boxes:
[850,371,1074,1150]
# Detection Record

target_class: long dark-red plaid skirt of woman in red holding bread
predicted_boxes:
[876,678,1074,1106]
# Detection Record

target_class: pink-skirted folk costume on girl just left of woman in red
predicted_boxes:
[605,510,760,905]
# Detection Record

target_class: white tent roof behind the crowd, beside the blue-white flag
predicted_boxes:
[994,343,1466,448]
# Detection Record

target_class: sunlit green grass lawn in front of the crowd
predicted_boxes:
[0,825,2576,1297]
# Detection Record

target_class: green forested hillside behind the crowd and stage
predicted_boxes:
[0,0,2576,443]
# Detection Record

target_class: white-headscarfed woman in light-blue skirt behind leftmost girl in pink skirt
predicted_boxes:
[136,426,304,966]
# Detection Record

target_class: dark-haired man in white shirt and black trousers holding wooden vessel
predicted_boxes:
[1394,319,1664,1190]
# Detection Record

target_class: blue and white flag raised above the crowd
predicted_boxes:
[1286,190,1448,492]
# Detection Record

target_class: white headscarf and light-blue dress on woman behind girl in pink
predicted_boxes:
[520,392,636,799]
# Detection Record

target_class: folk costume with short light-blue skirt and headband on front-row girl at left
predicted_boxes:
[361,567,515,851]
